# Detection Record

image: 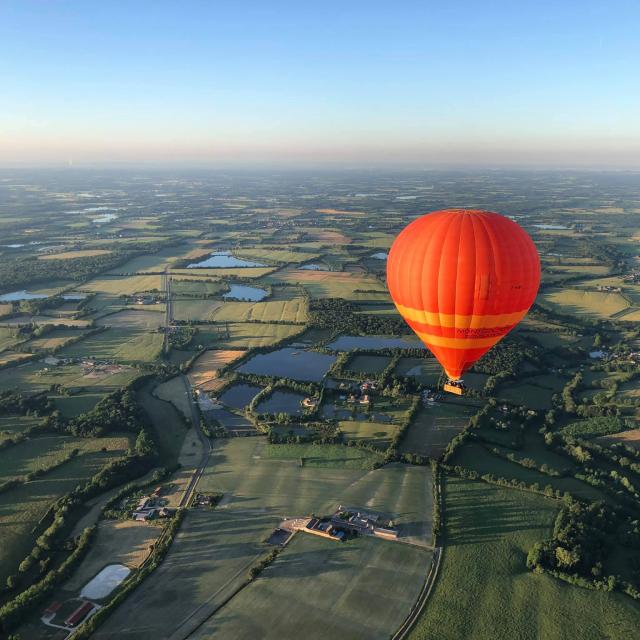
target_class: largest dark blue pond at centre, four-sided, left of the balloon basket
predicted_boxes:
[238,347,336,382]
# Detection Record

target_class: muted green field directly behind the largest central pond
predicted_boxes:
[195,322,301,350]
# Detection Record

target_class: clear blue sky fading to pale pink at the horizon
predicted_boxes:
[0,0,640,166]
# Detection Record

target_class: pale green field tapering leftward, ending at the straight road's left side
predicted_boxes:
[57,328,163,364]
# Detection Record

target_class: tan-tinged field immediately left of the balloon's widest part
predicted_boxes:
[268,268,388,299]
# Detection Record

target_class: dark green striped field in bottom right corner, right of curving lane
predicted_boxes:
[410,477,640,640]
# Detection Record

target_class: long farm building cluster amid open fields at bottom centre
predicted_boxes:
[302,505,398,541]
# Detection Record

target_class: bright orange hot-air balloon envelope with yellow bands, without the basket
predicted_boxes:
[387,209,540,380]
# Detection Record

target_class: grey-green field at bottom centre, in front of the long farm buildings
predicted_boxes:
[198,534,431,640]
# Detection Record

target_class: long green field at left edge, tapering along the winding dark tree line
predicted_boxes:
[0,437,129,580]
